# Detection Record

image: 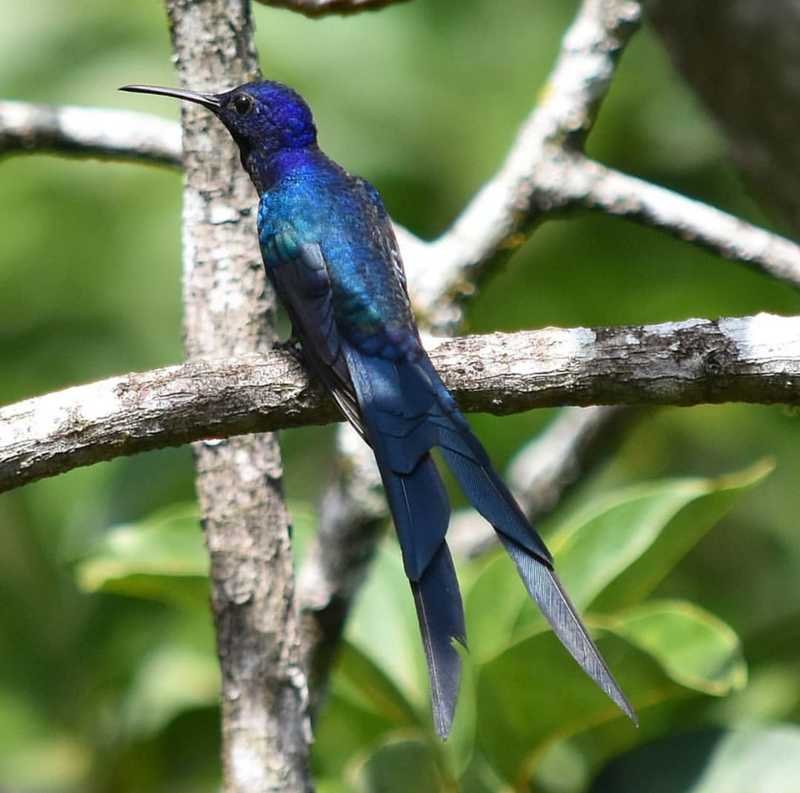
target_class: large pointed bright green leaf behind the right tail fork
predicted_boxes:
[466,462,772,663]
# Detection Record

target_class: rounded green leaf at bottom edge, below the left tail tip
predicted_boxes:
[354,738,446,793]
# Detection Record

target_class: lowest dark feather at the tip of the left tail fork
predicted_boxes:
[411,543,467,738]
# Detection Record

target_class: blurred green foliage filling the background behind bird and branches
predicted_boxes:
[0,0,800,793]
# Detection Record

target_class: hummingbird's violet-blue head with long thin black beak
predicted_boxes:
[120,80,317,162]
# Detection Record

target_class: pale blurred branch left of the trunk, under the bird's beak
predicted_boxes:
[0,101,182,165]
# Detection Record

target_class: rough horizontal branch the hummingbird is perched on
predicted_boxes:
[0,314,800,492]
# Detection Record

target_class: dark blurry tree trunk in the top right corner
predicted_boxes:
[646,0,800,232]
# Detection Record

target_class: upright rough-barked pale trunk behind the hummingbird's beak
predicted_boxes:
[167,0,310,793]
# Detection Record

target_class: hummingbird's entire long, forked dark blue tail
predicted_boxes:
[342,344,636,738]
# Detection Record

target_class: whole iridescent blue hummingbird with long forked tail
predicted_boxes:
[121,81,636,738]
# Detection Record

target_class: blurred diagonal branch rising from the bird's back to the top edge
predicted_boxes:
[401,0,641,328]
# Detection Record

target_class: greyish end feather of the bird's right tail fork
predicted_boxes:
[500,534,639,724]
